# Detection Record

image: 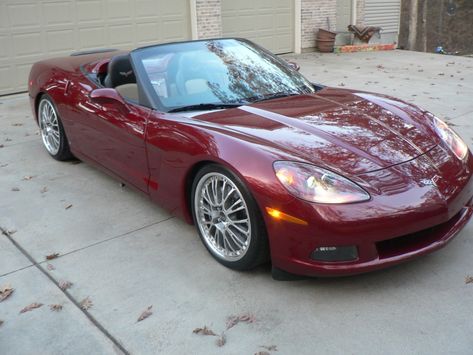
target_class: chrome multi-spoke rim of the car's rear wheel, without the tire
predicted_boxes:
[38,99,61,155]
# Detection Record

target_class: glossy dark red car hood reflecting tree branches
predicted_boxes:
[194,88,438,175]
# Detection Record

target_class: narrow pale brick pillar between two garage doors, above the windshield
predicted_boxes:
[196,0,222,38]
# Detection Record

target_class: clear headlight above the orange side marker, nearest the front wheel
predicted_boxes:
[274,161,370,204]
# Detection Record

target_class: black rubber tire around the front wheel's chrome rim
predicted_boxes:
[191,164,269,270]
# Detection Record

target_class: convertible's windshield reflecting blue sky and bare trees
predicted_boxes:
[134,39,315,112]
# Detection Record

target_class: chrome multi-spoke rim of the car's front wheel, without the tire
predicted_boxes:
[194,172,251,262]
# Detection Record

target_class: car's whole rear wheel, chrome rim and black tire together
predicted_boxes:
[38,94,74,161]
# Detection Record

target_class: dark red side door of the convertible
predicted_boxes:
[70,87,150,192]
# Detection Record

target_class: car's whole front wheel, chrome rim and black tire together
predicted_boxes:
[192,164,269,270]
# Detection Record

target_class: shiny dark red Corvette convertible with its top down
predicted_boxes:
[29,39,473,279]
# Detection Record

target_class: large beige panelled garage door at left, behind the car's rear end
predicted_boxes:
[0,0,190,95]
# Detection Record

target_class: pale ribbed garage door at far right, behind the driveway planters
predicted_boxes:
[365,0,401,43]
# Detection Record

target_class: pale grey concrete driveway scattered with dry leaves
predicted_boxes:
[0,51,473,355]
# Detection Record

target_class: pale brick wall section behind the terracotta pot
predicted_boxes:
[301,0,337,51]
